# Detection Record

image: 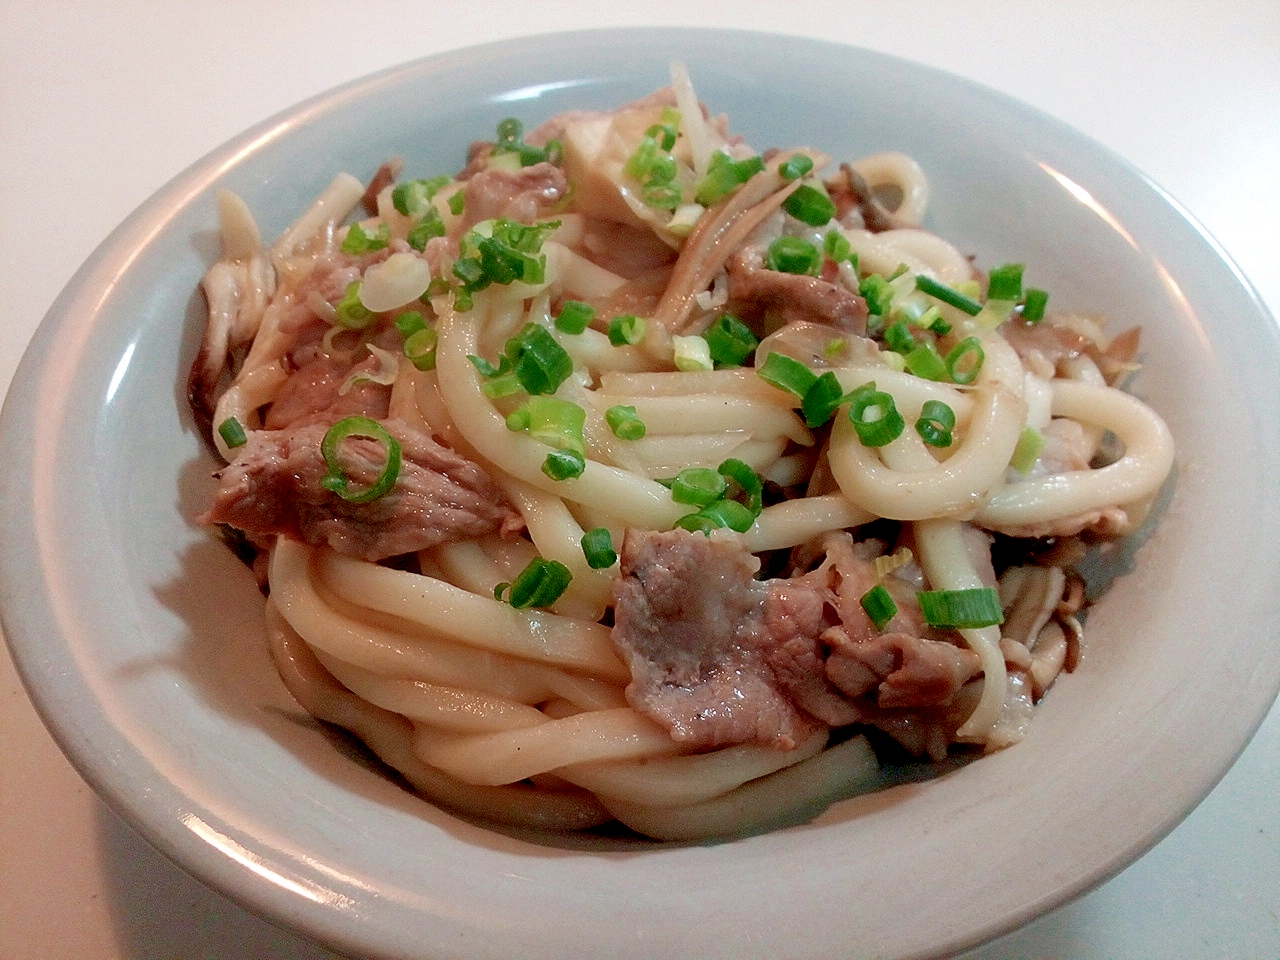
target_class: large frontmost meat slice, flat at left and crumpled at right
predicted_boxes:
[613,530,979,749]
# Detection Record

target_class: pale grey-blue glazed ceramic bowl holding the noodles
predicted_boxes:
[0,29,1280,960]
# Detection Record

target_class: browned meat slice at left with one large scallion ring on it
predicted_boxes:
[201,421,520,561]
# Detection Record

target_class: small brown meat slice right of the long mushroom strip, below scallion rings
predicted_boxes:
[726,247,867,335]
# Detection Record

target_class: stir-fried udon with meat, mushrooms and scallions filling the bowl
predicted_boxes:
[189,65,1172,838]
